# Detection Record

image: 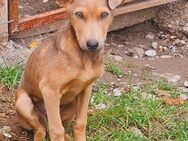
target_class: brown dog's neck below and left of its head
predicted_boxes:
[56,25,104,64]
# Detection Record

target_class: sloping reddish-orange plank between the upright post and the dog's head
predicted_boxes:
[18,8,67,31]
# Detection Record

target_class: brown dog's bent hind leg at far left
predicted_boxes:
[15,89,46,141]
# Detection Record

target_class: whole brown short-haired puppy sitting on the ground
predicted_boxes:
[16,0,122,141]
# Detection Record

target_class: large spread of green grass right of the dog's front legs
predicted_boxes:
[87,82,188,141]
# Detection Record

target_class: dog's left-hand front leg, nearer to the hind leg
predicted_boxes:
[41,83,65,141]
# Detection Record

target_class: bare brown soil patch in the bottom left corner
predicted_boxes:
[0,85,33,141]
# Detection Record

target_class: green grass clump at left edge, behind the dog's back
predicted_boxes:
[0,63,23,88]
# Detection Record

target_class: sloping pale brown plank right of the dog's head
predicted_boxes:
[114,0,177,16]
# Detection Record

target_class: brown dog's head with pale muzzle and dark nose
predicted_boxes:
[56,0,123,51]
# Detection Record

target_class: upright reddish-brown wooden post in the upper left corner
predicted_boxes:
[8,0,18,35]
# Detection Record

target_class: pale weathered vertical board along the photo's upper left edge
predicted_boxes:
[0,0,8,44]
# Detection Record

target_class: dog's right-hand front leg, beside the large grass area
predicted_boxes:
[74,85,92,141]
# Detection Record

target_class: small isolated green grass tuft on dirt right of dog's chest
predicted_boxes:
[105,60,124,76]
